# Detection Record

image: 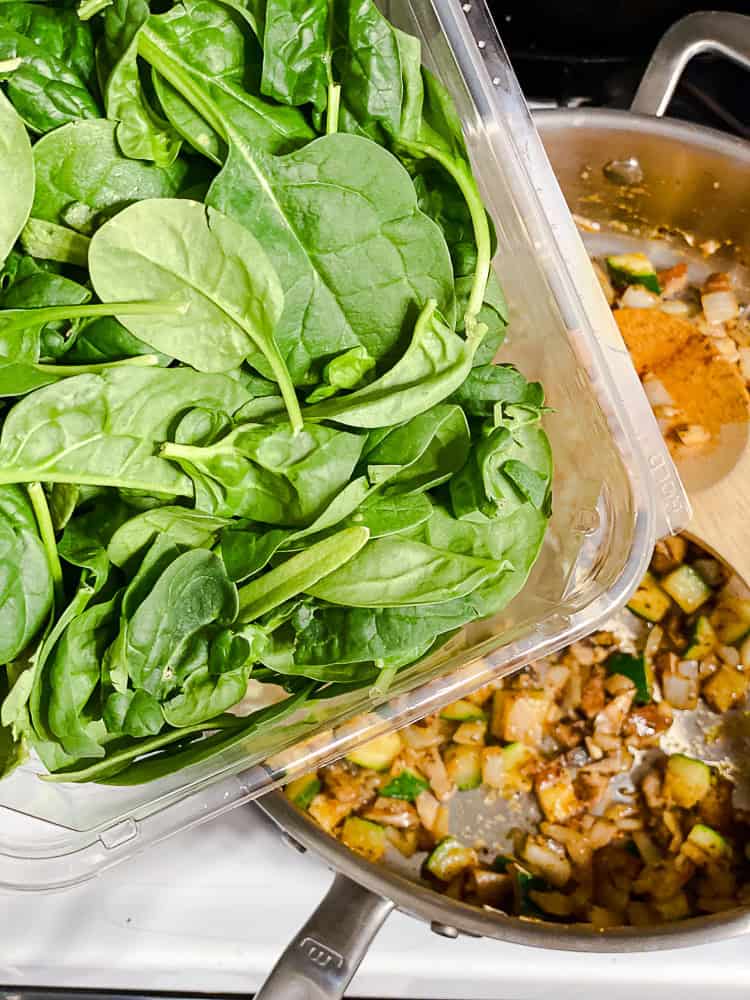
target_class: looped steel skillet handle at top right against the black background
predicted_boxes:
[630,11,750,118]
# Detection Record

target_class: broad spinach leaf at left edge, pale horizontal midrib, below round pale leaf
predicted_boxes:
[0,367,247,496]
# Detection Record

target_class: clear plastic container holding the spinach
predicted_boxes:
[0,0,689,889]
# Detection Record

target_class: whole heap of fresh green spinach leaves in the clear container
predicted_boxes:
[0,0,552,784]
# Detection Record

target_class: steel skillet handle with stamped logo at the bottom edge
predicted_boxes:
[255,875,393,1000]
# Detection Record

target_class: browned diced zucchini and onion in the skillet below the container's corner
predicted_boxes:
[286,537,750,929]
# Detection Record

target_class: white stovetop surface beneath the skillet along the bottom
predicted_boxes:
[0,808,750,1000]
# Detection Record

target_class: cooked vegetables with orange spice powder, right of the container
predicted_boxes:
[594,253,750,458]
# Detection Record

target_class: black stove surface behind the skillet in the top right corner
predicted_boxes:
[490,0,750,139]
